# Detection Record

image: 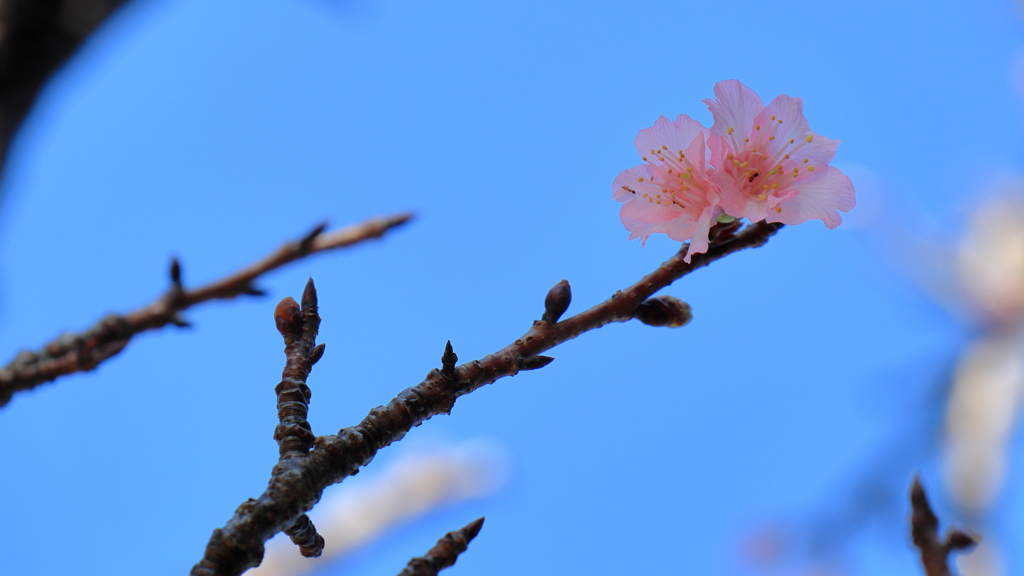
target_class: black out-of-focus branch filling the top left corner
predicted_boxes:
[0,0,132,171]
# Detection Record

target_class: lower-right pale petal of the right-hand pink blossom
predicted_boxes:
[766,166,857,230]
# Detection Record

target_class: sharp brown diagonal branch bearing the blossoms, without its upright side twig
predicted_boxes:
[191,217,782,576]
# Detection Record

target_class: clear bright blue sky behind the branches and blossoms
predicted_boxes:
[0,0,1024,575]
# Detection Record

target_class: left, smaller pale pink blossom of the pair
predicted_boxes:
[612,114,721,262]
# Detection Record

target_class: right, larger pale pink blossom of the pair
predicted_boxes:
[703,80,857,229]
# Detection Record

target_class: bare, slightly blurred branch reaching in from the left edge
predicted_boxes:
[0,210,413,406]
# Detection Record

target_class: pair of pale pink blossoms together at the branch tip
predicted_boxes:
[612,80,856,261]
